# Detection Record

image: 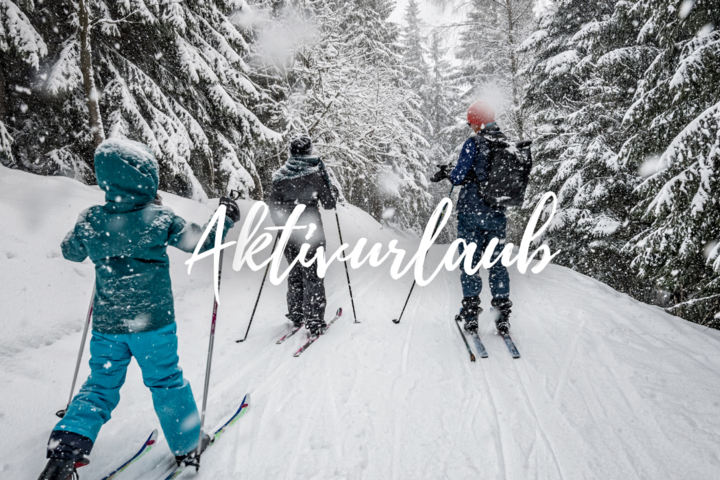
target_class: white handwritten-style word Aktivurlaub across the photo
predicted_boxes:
[185,192,560,303]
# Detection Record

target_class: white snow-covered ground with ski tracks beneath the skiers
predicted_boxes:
[0,167,720,480]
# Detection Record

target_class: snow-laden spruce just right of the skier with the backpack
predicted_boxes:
[524,0,655,300]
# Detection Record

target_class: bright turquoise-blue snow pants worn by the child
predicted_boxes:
[54,323,200,455]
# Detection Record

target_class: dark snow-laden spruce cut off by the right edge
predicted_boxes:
[621,0,720,327]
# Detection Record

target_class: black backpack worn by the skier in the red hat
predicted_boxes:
[472,135,532,207]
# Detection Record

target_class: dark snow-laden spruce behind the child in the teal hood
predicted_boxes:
[4,0,277,198]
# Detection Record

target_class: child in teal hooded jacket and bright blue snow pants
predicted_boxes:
[40,140,240,480]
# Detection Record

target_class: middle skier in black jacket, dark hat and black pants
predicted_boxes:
[268,136,337,335]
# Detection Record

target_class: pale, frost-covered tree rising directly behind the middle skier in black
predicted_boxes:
[254,0,432,231]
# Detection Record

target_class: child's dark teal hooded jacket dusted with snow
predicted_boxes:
[62,139,233,334]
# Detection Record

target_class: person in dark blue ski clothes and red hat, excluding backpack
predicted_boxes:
[431,101,512,333]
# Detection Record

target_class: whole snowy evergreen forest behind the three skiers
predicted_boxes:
[0,0,720,328]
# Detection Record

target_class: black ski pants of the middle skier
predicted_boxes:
[284,242,327,321]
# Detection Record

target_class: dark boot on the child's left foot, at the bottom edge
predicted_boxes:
[38,430,93,480]
